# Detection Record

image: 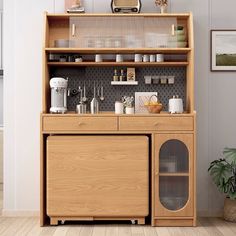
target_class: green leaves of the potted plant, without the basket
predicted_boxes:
[208,148,236,199]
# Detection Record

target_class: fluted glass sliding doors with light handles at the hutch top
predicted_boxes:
[70,16,177,48]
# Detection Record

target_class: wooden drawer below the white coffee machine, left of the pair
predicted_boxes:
[43,116,117,132]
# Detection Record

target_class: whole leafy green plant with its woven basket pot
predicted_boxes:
[208,148,236,222]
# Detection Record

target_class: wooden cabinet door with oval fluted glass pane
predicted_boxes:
[155,134,193,216]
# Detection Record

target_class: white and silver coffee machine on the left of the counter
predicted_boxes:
[50,77,68,113]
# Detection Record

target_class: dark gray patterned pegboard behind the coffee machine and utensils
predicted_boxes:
[50,67,186,111]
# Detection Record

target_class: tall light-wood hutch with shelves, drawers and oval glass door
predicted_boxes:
[40,13,196,226]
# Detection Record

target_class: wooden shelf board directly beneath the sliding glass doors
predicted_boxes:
[45,48,191,54]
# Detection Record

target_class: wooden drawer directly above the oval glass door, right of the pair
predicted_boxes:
[119,117,194,131]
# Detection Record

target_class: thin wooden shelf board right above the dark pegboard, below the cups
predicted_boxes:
[48,61,189,67]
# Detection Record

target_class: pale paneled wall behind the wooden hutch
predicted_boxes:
[4,0,236,214]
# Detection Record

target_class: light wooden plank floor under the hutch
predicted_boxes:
[0,186,236,236]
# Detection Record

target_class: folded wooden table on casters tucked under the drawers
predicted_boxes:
[47,135,149,224]
